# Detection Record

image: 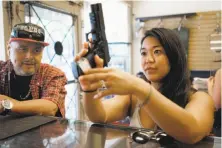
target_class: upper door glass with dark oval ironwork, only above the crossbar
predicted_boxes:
[25,6,74,81]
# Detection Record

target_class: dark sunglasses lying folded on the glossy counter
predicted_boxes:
[130,130,174,146]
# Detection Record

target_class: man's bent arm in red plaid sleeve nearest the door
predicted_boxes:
[0,71,67,117]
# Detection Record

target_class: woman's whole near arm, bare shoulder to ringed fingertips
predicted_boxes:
[81,69,214,143]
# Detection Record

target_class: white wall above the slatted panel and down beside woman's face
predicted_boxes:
[132,0,221,74]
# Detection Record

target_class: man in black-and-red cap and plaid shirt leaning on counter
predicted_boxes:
[0,23,67,117]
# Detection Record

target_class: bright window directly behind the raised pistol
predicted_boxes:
[84,2,131,72]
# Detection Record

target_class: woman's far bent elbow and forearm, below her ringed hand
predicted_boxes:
[83,93,130,123]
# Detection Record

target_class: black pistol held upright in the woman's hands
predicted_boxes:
[72,3,110,79]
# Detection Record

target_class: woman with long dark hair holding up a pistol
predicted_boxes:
[75,28,214,144]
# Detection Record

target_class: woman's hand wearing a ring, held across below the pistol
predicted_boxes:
[79,68,139,99]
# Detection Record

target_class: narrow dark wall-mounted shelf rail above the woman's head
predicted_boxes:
[136,13,196,22]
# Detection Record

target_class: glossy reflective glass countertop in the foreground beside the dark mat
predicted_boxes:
[0,116,221,148]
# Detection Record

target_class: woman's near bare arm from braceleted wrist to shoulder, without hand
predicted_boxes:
[135,83,214,144]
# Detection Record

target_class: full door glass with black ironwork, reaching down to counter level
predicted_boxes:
[25,4,78,119]
